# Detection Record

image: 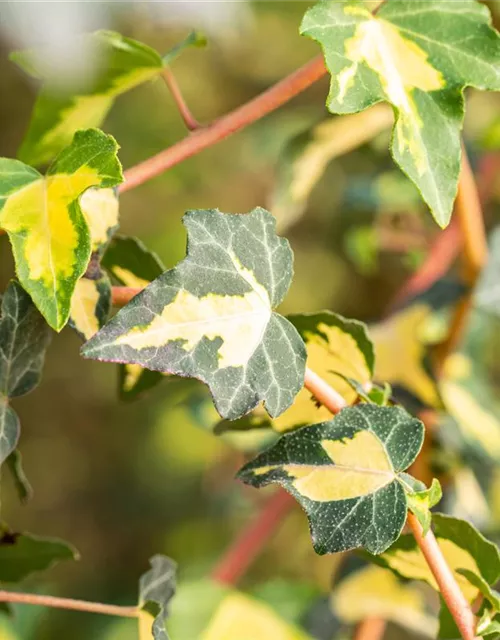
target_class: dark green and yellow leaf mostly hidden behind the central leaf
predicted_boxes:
[101,236,165,400]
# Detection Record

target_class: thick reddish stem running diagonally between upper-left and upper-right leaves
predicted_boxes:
[119,55,327,193]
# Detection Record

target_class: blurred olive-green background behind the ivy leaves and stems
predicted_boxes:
[0,0,500,640]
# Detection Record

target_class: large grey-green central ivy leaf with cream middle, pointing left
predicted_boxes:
[82,208,306,418]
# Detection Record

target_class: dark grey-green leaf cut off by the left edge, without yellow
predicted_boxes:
[0,281,51,465]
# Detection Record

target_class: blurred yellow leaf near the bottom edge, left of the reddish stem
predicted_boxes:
[330,566,437,638]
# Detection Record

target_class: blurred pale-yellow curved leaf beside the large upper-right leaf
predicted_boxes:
[269,105,393,229]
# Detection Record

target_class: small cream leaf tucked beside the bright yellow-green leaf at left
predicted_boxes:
[80,188,119,255]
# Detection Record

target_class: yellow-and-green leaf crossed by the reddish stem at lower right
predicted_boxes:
[372,513,500,603]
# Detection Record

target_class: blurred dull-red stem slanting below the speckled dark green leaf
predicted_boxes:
[212,489,295,585]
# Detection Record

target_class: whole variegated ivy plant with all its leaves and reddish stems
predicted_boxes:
[0,0,500,640]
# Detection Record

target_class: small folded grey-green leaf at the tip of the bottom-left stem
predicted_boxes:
[139,555,177,640]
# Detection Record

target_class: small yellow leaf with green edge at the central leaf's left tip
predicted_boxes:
[69,273,111,340]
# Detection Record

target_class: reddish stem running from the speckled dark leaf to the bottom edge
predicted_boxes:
[407,513,476,640]
